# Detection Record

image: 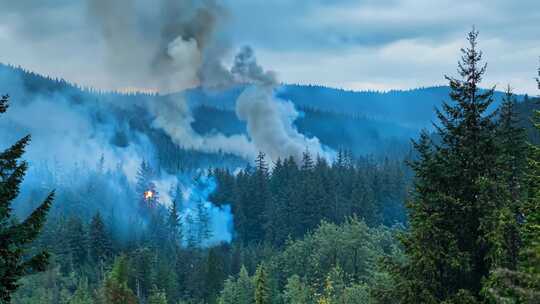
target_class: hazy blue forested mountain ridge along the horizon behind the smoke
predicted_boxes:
[0,65,532,163]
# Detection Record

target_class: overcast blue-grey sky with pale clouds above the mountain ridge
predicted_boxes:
[0,0,540,95]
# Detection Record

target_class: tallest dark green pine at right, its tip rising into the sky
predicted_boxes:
[397,30,503,303]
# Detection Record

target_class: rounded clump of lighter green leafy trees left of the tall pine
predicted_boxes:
[276,218,399,286]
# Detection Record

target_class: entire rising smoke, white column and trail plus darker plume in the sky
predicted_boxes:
[89,0,330,164]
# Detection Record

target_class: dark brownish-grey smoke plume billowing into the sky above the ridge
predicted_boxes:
[88,0,226,92]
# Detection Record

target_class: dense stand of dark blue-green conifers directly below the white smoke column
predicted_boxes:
[211,151,407,246]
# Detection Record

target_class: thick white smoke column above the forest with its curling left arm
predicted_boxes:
[149,47,332,161]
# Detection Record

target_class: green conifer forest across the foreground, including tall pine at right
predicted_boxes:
[0,30,540,304]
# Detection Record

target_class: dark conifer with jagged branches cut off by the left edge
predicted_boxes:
[0,96,54,303]
